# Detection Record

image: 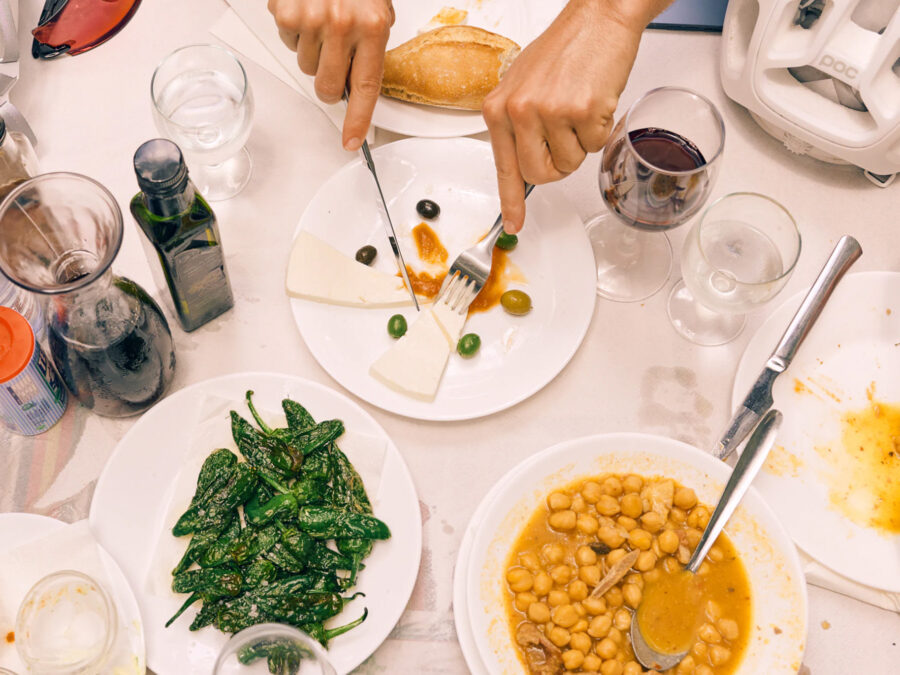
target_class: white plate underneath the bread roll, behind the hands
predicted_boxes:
[372,0,563,138]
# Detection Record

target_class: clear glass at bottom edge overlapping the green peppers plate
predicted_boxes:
[213,623,337,675]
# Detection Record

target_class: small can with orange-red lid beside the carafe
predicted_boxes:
[0,307,68,436]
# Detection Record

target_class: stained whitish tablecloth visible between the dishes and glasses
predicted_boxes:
[0,0,900,675]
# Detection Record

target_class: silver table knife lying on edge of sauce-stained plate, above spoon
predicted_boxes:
[713,235,862,459]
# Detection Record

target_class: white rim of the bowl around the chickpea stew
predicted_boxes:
[466,433,807,675]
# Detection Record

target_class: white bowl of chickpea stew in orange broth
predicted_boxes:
[466,434,807,675]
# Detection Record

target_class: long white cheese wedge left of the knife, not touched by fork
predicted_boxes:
[285,232,412,307]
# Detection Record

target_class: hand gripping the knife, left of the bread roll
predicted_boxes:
[269,0,394,150]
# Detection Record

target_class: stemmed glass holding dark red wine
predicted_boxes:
[585,87,725,302]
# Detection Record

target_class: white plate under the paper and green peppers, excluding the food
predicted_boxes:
[90,373,422,675]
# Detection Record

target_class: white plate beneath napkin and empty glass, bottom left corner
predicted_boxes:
[0,513,145,672]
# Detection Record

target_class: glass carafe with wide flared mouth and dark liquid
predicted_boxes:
[0,173,175,417]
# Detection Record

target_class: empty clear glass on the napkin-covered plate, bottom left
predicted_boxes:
[16,570,118,675]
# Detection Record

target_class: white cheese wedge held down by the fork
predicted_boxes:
[369,309,455,401]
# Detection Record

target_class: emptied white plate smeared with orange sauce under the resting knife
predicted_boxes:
[732,272,900,592]
